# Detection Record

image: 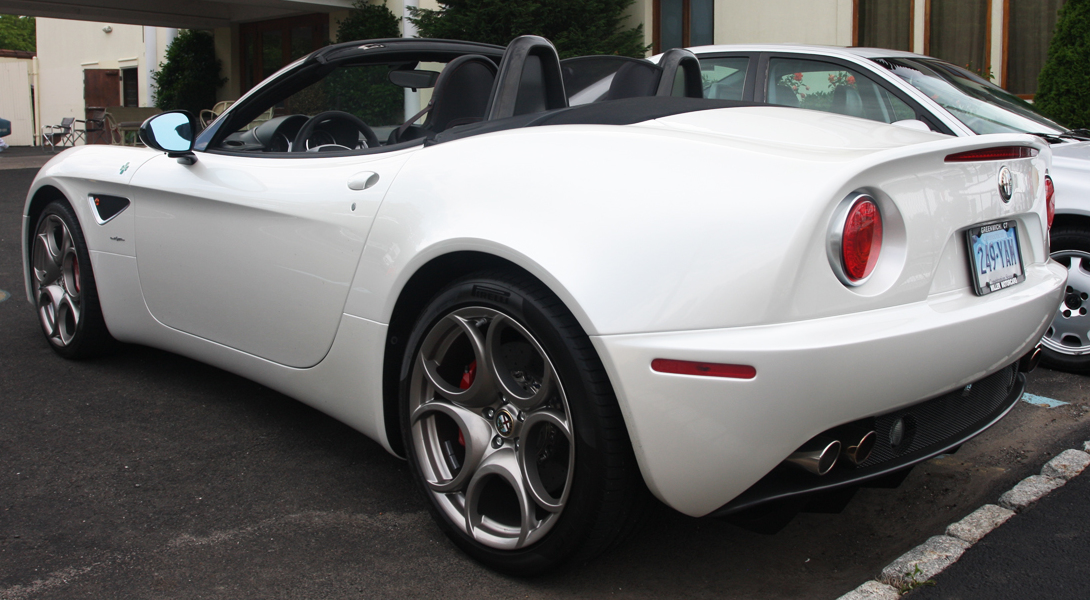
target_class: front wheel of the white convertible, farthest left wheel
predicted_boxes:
[31,201,113,358]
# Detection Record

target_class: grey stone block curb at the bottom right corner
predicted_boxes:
[837,442,1090,600]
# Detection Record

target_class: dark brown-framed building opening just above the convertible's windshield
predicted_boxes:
[239,13,329,93]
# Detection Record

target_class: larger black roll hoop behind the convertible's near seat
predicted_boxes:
[485,35,568,121]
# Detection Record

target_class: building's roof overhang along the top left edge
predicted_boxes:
[0,0,352,29]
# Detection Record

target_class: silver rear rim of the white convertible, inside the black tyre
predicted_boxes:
[409,307,576,549]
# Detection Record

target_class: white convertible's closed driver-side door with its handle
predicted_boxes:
[132,153,407,368]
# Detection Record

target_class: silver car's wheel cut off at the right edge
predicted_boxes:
[1041,226,1090,373]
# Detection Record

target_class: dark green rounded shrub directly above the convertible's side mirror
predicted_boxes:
[152,29,227,115]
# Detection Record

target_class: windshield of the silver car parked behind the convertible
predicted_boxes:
[874,58,1066,134]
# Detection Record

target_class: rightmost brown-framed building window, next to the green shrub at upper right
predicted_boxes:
[1003,0,1064,96]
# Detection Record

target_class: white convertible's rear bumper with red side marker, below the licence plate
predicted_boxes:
[593,262,1066,516]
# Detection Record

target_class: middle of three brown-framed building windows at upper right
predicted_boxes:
[923,0,992,79]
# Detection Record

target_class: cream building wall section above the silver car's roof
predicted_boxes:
[710,0,852,46]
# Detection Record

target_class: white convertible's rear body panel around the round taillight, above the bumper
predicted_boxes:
[346,107,1047,335]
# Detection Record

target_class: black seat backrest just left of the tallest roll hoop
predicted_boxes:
[424,55,496,133]
